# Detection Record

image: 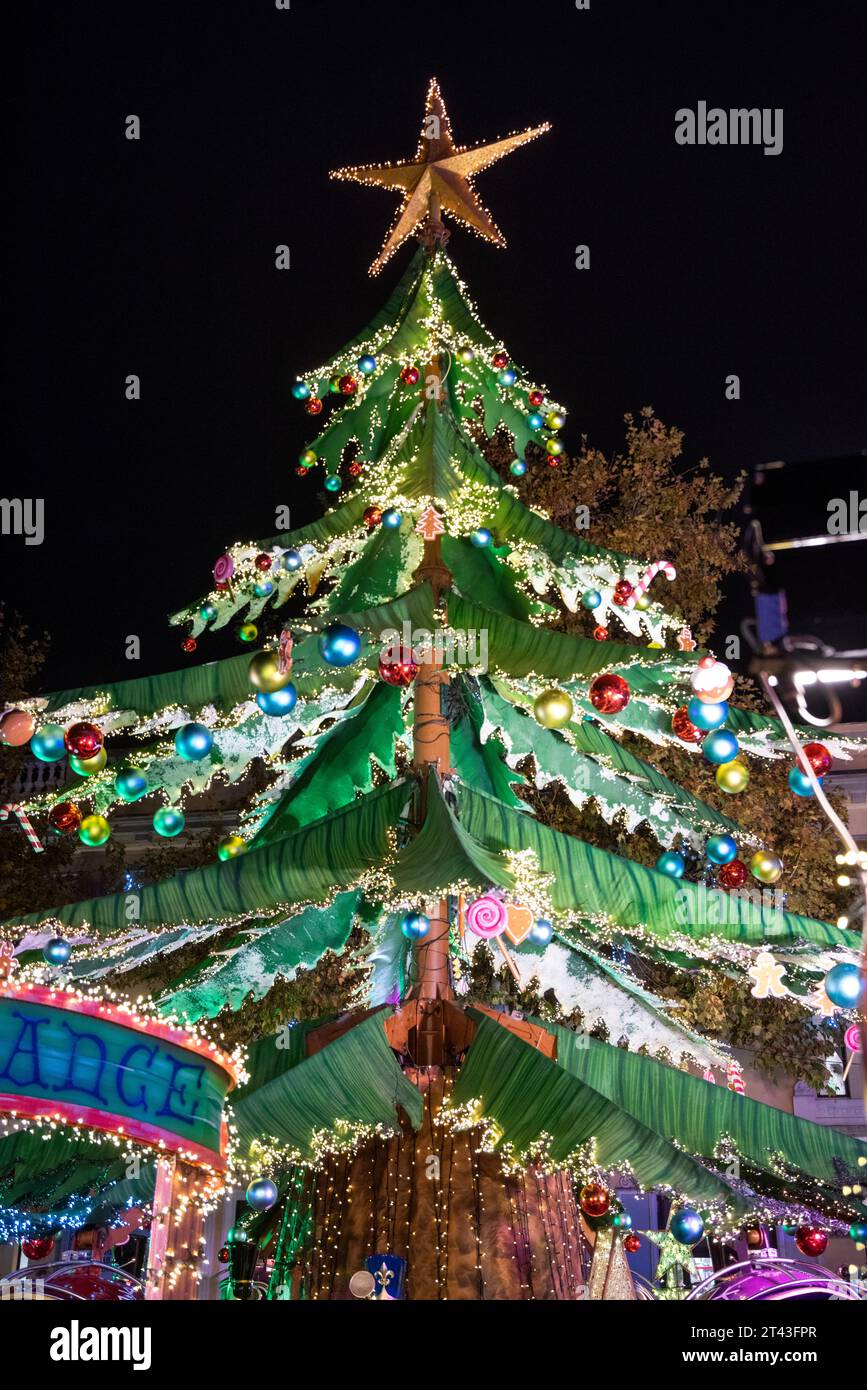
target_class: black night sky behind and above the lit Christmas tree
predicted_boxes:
[11,0,867,688]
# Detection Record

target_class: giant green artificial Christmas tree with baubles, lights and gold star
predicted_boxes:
[0,83,864,1298]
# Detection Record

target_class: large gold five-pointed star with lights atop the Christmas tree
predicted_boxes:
[331,78,550,275]
